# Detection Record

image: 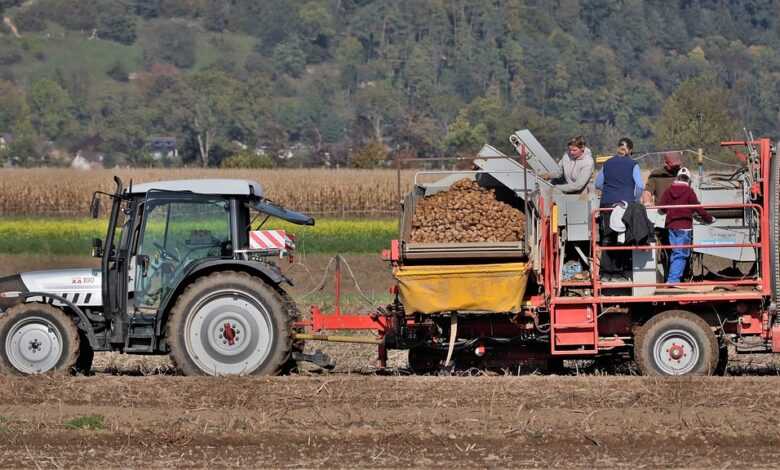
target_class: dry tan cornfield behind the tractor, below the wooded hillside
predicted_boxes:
[0,168,414,217]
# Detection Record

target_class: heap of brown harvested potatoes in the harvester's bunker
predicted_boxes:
[410,179,525,243]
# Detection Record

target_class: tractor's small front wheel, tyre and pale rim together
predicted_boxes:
[0,303,80,375]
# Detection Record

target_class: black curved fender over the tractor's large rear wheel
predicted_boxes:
[155,259,293,335]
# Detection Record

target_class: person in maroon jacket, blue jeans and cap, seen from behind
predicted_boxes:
[658,167,715,284]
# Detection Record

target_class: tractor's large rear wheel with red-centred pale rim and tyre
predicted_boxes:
[167,271,292,375]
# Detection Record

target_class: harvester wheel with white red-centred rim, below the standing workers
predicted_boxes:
[634,310,718,375]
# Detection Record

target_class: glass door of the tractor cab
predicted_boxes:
[134,195,232,315]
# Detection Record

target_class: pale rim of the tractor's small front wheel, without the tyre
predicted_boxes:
[5,317,62,374]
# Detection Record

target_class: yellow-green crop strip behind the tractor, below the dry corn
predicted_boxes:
[0,218,398,256]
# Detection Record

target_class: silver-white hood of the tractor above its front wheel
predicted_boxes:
[0,268,102,309]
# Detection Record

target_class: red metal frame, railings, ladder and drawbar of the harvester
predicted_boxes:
[295,138,780,366]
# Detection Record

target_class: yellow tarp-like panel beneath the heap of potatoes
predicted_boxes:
[393,263,528,314]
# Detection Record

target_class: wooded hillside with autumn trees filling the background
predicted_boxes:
[0,0,780,167]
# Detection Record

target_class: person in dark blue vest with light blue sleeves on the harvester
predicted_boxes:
[596,137,645,278]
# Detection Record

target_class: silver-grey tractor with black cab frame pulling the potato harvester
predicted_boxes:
[0,177,314,375]
